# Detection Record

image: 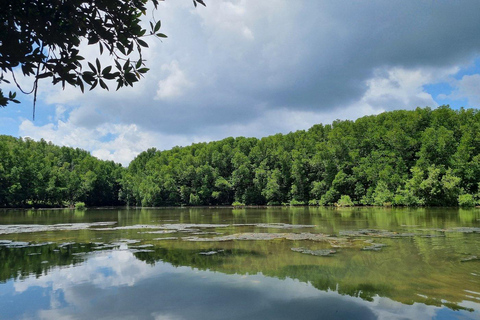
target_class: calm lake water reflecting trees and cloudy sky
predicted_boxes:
[0,208,480,320]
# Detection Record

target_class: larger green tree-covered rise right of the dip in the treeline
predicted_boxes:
[121,106,480,206]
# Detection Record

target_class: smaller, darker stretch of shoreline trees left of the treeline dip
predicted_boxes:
[0,135,124,207]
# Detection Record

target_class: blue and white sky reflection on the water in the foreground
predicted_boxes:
[0,250,479,319]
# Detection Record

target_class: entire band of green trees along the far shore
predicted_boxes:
[0,106,480,206]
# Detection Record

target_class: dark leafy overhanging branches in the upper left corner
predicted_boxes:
[0,0,205,114]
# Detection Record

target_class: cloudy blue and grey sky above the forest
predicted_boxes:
[0,0,480,165]
